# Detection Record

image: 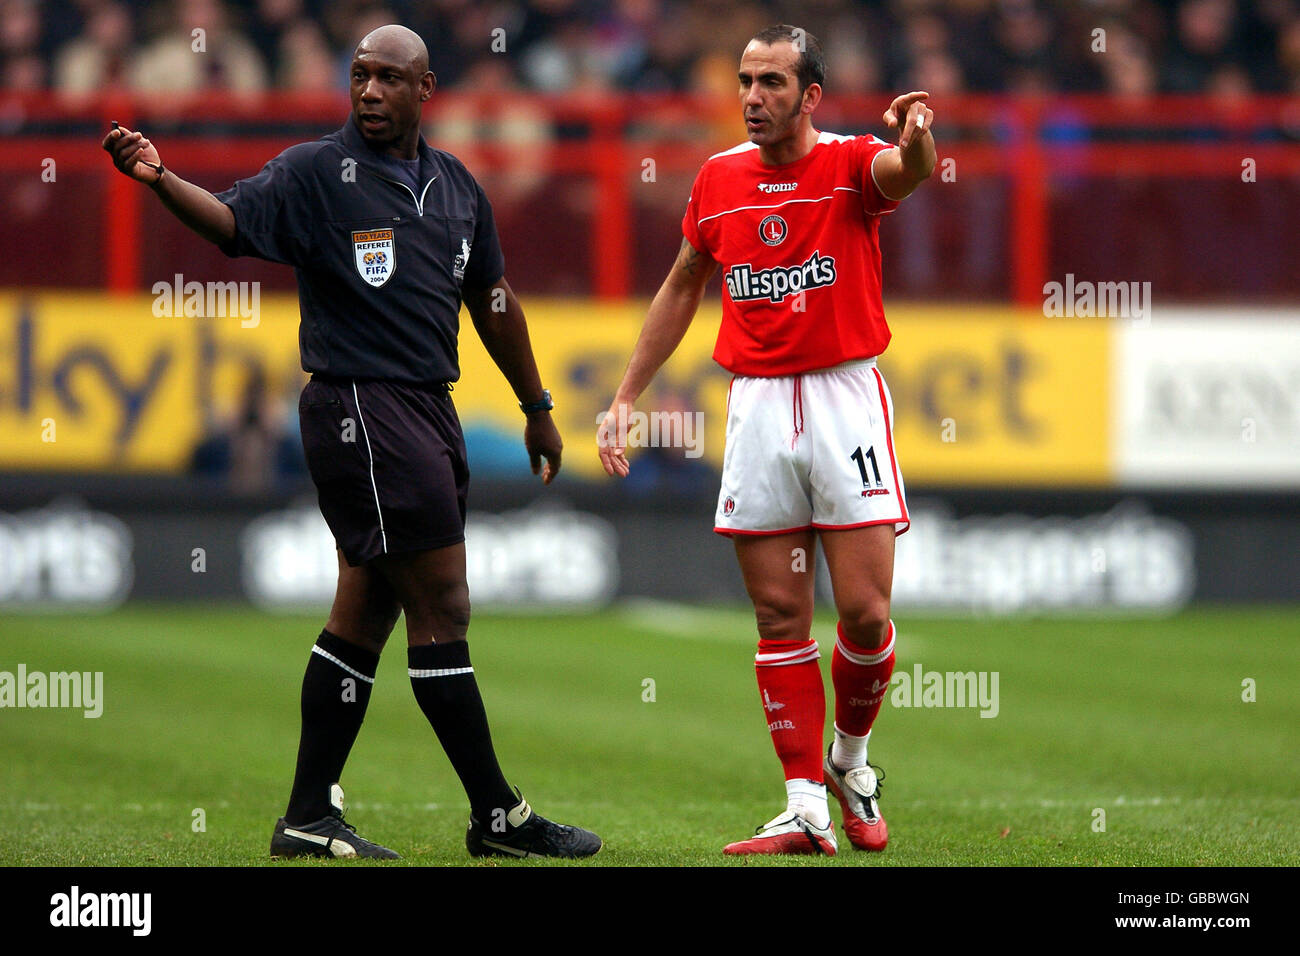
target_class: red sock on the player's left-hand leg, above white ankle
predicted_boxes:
[754,640,826,780]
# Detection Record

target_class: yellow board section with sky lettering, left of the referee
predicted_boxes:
[0,293,306,472]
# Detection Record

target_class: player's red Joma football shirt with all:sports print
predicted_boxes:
[681,133,898,376]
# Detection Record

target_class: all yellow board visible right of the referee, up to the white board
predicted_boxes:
[455,303,1114,486]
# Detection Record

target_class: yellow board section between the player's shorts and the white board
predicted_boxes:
[880,308,1117,486]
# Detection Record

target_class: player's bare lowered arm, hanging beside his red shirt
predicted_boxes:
[595,239,718,477]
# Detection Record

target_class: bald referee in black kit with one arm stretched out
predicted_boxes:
[104,25,601,858]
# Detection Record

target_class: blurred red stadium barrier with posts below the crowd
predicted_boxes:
[0,92,1300,306]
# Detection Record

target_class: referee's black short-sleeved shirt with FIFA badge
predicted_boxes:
[217,117,506,385]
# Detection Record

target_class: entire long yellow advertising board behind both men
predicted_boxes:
[0,293,1114,486]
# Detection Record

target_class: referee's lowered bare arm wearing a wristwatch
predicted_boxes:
[463,276,564,485]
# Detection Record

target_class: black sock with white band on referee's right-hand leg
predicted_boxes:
[407,641,519,823]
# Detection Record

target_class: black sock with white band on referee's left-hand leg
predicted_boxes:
[285,631,380,825]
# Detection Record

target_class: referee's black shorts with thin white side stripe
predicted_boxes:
[298,375,469,567]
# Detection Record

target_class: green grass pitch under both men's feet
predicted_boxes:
[0,605,1300,866]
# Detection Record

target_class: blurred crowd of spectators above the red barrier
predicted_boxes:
[0,0,1300,94]
